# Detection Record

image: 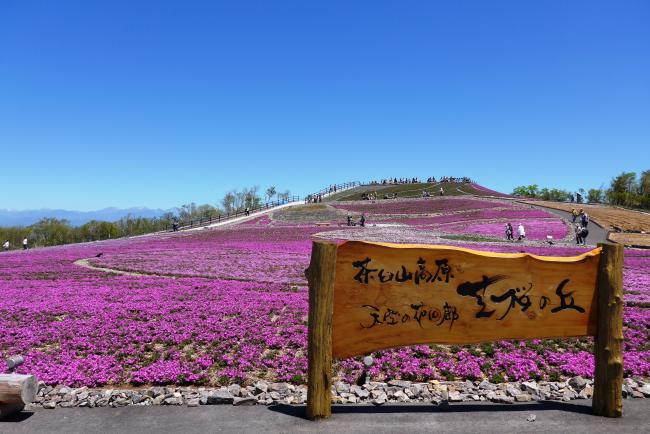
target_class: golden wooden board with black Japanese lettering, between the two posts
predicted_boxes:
[332,241,600,358]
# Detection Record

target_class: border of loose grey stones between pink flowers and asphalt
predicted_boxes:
[27,377,650,409]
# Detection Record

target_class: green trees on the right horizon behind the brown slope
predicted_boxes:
[512,170,650,209]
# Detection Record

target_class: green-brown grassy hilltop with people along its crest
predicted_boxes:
[324,182,506,202]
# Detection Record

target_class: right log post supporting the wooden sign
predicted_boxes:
[592,243,623,417]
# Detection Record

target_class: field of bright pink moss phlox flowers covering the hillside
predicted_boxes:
[0,197,650,386]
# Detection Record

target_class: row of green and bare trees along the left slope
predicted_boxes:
[0,186,290,249]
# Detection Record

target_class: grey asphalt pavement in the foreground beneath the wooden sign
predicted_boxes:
[0,399,650,434]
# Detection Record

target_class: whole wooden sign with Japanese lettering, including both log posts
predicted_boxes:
[306,241,623,419]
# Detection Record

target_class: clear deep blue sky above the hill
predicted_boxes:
[0,0,650,210]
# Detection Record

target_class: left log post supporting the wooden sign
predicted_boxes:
[305,241,337,420]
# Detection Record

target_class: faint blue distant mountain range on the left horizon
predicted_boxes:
[0,208,175,226]
